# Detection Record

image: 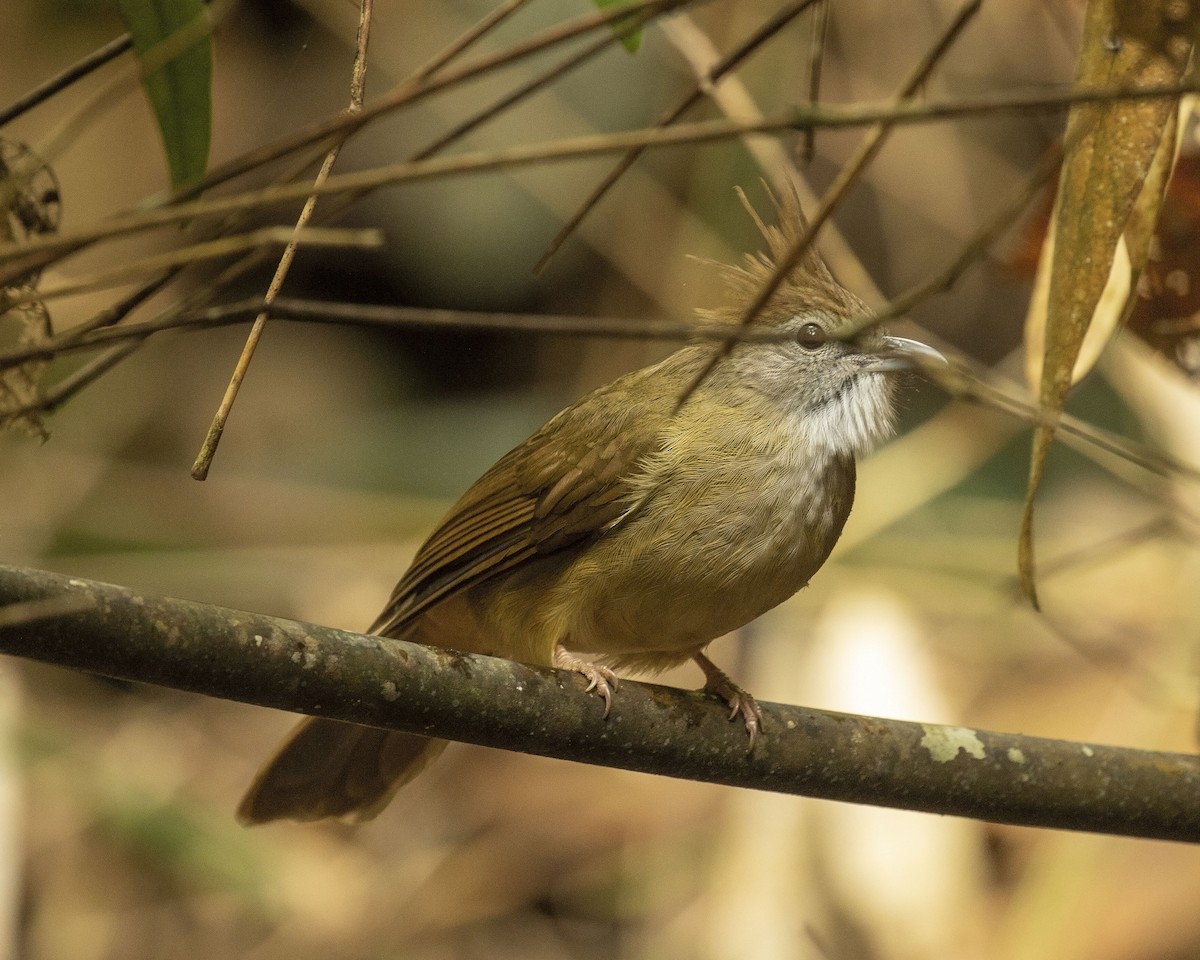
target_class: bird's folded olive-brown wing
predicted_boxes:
[371,371,673,635]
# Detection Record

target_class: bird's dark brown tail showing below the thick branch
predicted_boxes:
[238,718,446,826]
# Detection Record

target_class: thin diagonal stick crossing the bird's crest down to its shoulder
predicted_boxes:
[676,0,983,410]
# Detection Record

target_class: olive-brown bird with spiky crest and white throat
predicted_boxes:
[238,183,941,824]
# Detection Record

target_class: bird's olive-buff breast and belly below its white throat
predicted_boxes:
[546,425,854,666]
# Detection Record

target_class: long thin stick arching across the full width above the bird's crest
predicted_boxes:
[7,82,1200,283]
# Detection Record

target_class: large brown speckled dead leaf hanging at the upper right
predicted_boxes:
[1018,0,1200,606]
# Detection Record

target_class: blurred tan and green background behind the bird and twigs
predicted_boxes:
[0,0,1200,960]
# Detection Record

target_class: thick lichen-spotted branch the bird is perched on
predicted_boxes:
[0,565,1200,842]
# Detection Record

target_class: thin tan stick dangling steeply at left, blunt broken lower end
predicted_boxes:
[191,0,373,480]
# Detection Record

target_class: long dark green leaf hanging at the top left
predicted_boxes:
[118,0,212,187]
